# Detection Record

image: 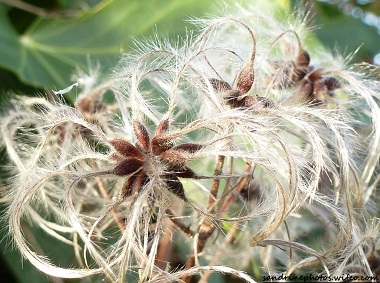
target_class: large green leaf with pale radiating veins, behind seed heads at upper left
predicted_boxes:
[0,0,211,88]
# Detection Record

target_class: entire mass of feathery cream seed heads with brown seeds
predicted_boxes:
[0,1,380,282]
